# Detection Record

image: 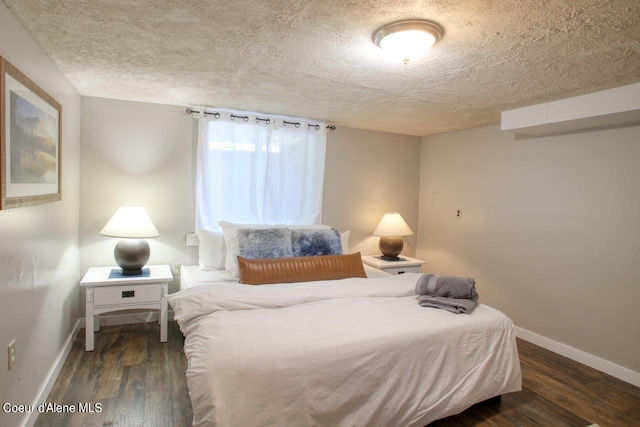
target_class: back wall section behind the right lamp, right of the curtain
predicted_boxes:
[323,127,420,256]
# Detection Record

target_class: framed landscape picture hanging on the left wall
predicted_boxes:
[0,56,62,209]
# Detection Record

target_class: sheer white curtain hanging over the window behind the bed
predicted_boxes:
[196,110,326,230]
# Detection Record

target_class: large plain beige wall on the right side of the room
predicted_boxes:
[418,126,640,378]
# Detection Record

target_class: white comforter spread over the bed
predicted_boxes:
[168,273,521,426]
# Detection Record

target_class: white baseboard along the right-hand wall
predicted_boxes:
[516,327,640,387]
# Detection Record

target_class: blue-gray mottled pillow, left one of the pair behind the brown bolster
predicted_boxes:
[238,228,293,259]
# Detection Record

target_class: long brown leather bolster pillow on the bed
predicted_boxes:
[238,252,367,285]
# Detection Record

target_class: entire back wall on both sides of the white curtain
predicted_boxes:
[80,97,421,300]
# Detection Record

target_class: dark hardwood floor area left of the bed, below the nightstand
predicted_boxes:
[35,322,192,427]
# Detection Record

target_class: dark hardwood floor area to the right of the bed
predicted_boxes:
[431,339,640,427]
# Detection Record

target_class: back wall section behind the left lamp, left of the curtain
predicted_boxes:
[80,97,198,292]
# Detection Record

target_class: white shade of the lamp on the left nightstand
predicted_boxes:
[100,205,160,239]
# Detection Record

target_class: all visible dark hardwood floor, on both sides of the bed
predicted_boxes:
[36,322,640,427]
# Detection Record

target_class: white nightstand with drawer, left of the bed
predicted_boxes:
[80,265,173,351]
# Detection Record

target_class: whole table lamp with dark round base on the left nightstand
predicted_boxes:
[100,205,160,276]
